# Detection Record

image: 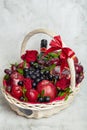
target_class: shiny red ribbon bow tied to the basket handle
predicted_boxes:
[45,36,75,72]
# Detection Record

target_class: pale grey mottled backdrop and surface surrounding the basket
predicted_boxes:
[0,0,87,130]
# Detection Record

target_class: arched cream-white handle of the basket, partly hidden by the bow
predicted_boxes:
[21,29,75,91]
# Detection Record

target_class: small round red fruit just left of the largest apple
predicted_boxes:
[26,89,38,102]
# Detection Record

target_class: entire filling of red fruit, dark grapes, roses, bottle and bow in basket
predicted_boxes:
[3,36,84,103]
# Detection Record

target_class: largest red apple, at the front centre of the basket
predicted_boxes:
[37,80,57,100]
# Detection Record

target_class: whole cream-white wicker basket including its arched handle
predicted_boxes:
[2,29,80,118]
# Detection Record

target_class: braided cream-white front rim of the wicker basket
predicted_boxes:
[1,84,80,110]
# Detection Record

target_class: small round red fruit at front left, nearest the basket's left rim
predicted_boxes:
[11,85,23,99]
